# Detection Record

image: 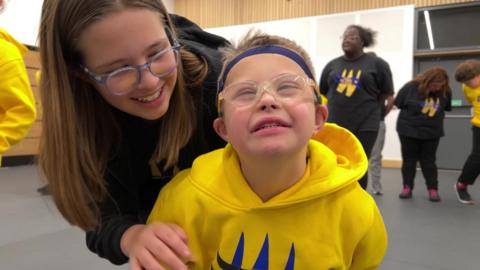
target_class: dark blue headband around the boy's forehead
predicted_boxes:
[217,45,315,90]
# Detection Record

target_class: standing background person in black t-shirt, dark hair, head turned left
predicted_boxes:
[320,25,393,189]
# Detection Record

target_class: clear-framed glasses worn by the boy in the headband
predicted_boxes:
[218,74,316,108]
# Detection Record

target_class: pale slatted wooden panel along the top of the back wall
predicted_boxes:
[175,0,474,28]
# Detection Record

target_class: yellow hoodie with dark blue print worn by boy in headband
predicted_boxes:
[148,124,387,270]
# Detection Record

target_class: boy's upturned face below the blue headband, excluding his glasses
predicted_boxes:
[214,54,326,159]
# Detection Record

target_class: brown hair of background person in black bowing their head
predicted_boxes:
[413,67,452,98]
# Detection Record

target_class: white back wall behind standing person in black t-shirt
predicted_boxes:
[207,6,414,160]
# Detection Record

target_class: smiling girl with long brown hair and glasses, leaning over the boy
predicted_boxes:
[39,0,227,269]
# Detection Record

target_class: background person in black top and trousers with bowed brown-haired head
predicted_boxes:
[395,67,452,202]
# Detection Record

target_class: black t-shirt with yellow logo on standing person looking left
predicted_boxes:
[320,54,393,133]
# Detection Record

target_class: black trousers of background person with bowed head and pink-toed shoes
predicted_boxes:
[399,135,440,189]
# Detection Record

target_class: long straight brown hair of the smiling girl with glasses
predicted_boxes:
[39,0,202,230]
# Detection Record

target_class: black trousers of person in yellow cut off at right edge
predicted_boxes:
[458,126,480,185]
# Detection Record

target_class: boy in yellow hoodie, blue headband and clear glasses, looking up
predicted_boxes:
[148,33,387,269]
